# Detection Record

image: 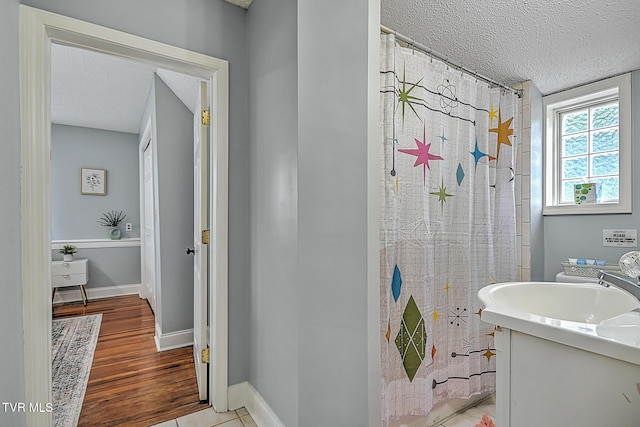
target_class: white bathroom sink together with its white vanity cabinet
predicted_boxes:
[478,282,640,427]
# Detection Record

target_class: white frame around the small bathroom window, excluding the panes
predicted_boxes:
[542,73,632,215]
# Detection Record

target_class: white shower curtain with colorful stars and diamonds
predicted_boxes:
[380,35,520,425]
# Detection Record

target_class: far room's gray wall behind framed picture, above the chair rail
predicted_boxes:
[51,125,140,240]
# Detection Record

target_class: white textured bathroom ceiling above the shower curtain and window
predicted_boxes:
[380,0,640,95]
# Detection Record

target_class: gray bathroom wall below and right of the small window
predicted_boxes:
[544,71,640,280]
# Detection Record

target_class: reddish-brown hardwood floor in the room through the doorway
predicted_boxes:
[53,295,207,427]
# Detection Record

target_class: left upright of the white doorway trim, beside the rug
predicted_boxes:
[19,5,52,427]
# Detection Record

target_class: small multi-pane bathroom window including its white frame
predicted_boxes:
[543,74,631,215]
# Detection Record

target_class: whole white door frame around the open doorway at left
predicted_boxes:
[20,5,229,426]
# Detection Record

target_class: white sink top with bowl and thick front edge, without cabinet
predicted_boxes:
[478,282,640,365]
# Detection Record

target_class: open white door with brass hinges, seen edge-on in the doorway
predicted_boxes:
[192,82,208,401]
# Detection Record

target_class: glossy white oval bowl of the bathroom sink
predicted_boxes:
[478,282,640,324]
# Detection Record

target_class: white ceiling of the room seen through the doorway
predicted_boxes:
[51,44,199,134]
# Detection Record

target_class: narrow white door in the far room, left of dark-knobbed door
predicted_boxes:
[142,140,156,313]
